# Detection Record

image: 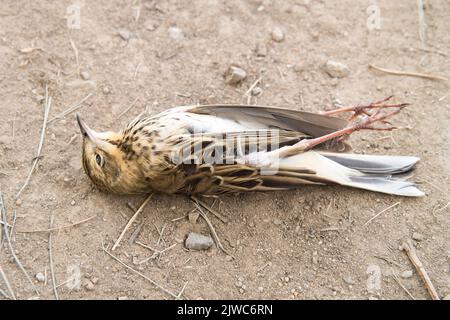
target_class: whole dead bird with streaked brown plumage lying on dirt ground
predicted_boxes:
[77,100,423,196]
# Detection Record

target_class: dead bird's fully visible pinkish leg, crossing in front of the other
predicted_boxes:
[278,104,408,158]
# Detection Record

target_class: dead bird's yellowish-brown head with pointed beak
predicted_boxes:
[77,115,141,193]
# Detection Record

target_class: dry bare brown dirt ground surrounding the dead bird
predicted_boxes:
[0,0,450,299]
